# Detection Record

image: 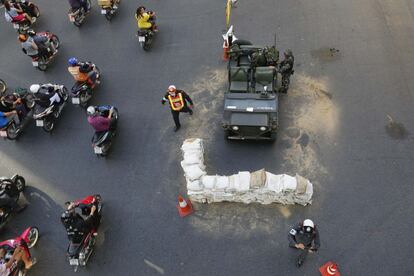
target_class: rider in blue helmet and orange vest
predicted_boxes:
[68,57,97,89]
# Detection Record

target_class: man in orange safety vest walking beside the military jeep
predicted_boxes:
[161,85,193,131]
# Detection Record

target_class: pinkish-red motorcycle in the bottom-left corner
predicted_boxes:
[0,227,39,276]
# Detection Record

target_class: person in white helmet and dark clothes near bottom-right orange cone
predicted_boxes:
[288,219,321,267]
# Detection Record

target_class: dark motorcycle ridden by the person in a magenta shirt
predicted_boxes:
[92,105,119,156]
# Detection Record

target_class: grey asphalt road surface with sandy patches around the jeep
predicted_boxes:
[0,0,414,275]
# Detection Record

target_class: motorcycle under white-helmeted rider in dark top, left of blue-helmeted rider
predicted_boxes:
[33,85,69,132]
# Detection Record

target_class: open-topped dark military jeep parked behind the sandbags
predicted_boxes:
[223,36,279,141]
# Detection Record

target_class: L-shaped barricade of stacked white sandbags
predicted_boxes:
[181,139,313,206]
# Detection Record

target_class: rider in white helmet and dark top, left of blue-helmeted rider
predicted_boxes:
[30,83,63,108]
